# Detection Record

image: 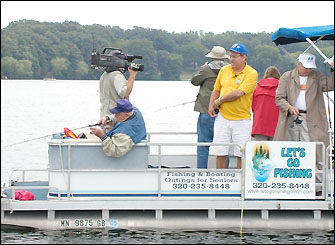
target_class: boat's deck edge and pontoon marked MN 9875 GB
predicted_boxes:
[1,192,334,231]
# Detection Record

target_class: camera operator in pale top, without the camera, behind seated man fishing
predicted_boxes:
[99,58,137,117]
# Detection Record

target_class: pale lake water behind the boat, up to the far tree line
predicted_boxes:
[1,80,198,183]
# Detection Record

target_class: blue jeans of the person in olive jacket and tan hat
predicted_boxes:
[197,113,215,168]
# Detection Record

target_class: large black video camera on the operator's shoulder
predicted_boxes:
[91,48,144,73]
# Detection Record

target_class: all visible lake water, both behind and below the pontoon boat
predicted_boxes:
[1,80,334,244]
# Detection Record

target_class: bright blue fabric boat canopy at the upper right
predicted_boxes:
[271,25,334,45]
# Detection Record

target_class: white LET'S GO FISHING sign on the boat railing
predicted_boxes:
[245,141,316,199]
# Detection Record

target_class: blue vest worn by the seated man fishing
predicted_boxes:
[106,107,147,144]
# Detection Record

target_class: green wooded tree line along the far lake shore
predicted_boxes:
[1,20,334,80]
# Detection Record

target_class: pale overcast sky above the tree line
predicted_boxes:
[1,1,334,34]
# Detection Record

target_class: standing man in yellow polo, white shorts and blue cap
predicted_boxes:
[208,43,258,168]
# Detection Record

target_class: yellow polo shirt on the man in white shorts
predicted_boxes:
[214,64,258,121]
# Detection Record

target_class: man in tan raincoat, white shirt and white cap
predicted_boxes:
[274,53,334,146]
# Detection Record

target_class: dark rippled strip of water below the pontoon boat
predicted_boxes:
[1,229,334,244]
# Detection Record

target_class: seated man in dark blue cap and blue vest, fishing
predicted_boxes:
[90,99,147,157]
